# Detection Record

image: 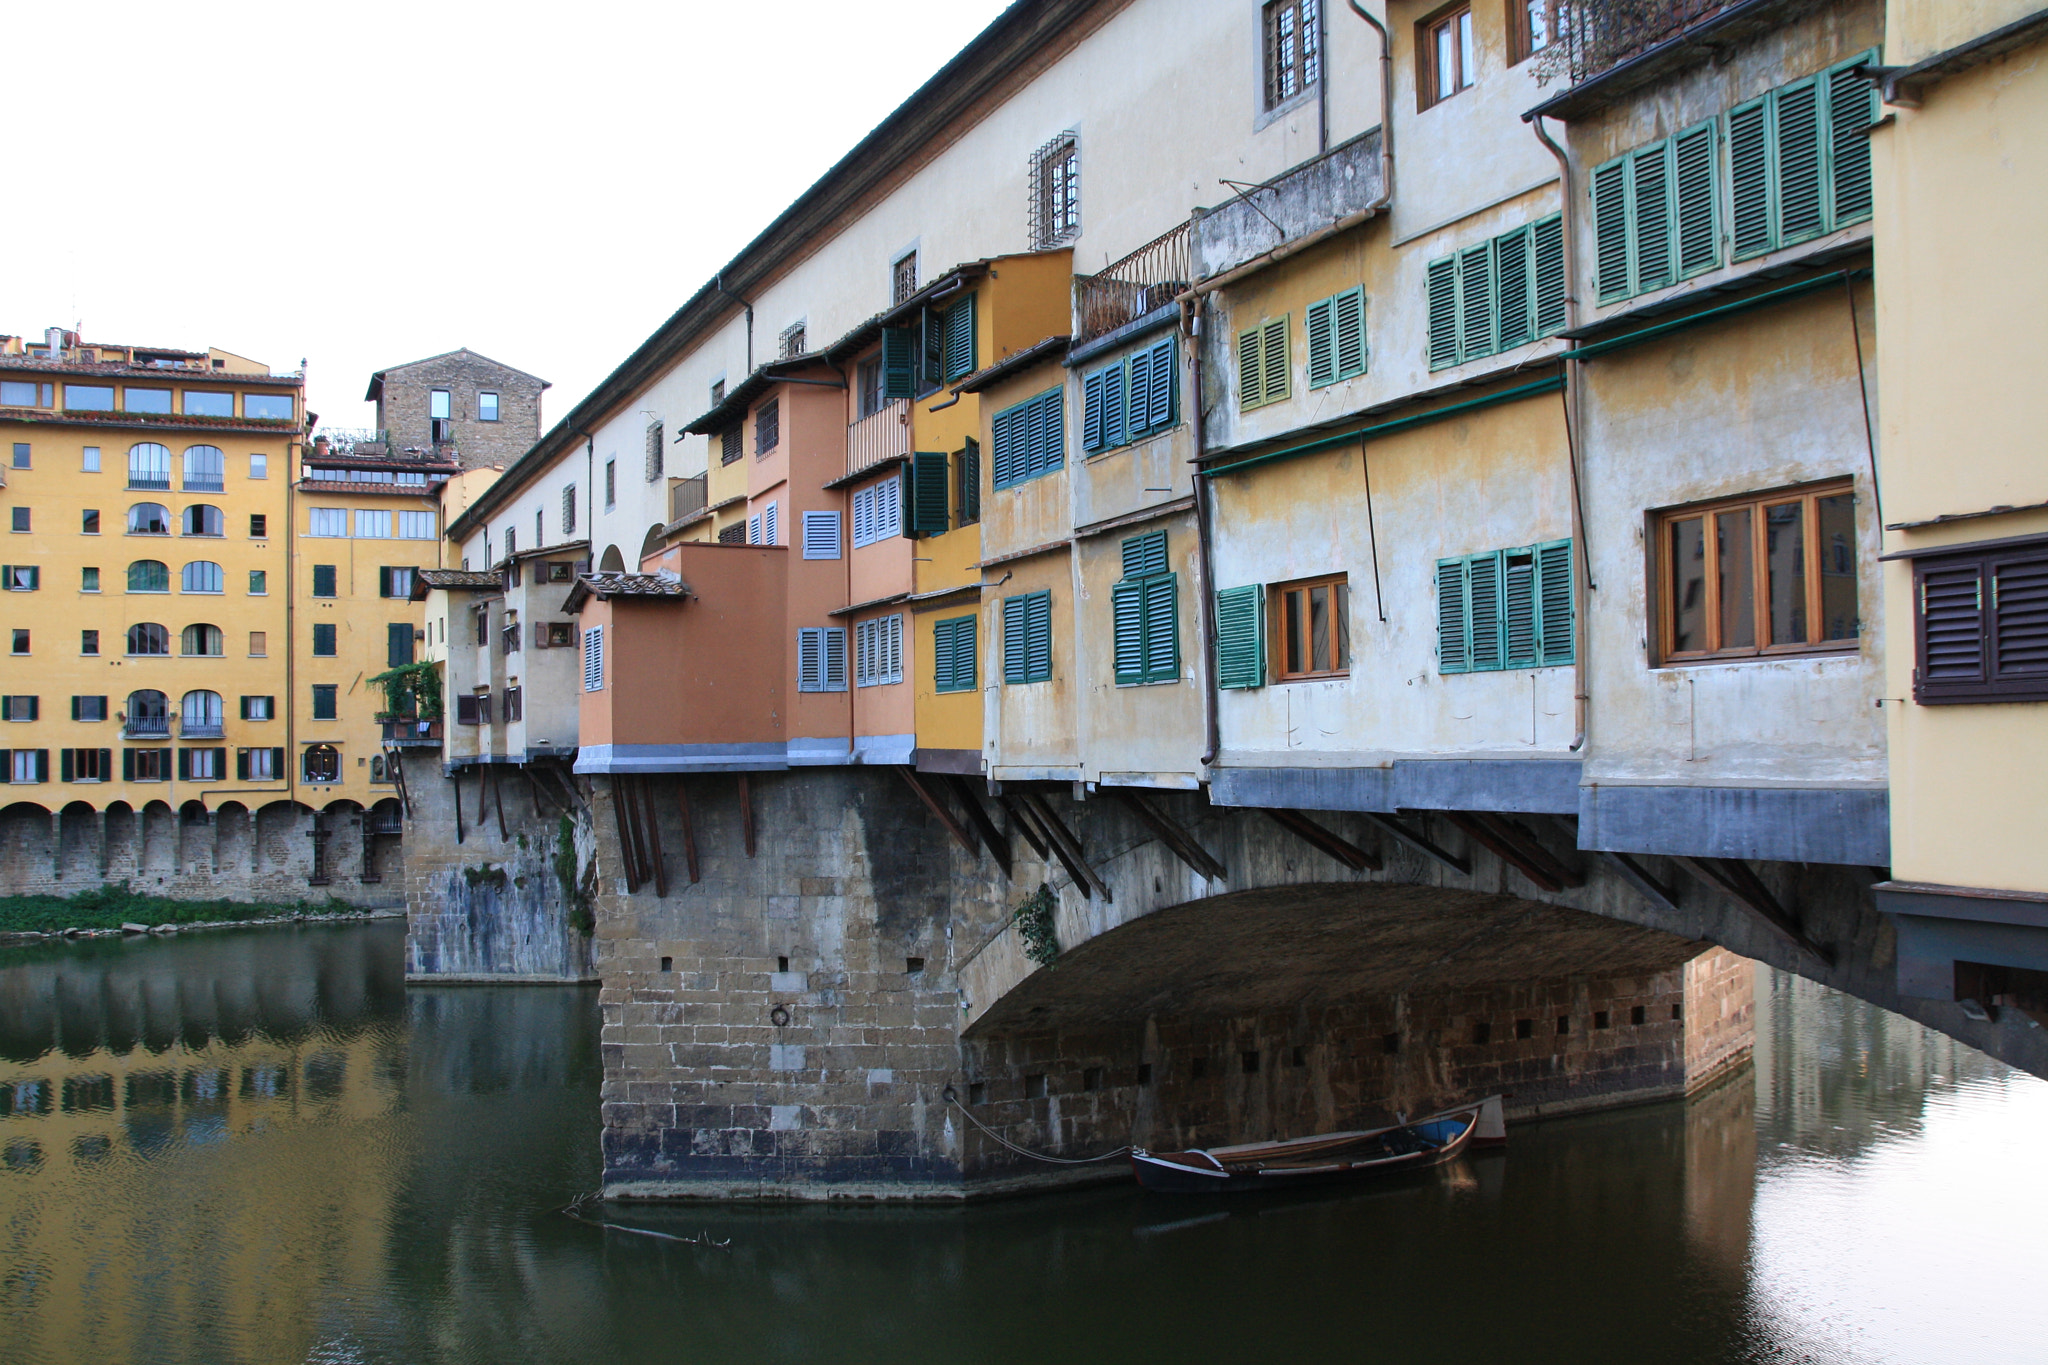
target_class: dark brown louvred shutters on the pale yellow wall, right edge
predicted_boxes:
[1913,540,2048,706]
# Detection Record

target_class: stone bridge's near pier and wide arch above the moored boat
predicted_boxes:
[565,767,2048,1197]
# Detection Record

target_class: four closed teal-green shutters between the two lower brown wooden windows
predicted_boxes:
[1436,540,1573,673]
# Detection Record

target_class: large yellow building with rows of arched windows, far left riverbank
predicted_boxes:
[0,329,305,812]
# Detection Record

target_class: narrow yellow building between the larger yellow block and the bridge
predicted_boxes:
[293,436,460,806]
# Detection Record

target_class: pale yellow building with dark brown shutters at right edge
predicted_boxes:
[1872,0,2048,1017]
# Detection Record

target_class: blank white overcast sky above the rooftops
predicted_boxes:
[0,0,1006,428]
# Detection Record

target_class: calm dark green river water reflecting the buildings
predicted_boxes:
[0,925,2048,1365]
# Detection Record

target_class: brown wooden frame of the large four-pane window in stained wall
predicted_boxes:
[1649,477,1868,667]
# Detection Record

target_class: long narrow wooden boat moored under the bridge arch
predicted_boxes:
[1130,1095,1505,1195]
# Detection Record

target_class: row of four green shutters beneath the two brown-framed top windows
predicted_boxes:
[1427,215,1565,370]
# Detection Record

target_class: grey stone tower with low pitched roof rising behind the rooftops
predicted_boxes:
[362,348,547,469]
